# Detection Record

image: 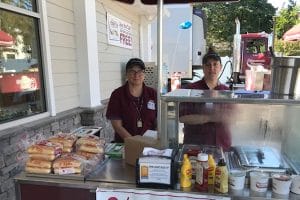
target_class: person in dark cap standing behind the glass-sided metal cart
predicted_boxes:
[179,49,231,150]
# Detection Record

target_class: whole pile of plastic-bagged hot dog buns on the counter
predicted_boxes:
[25,133,105,175]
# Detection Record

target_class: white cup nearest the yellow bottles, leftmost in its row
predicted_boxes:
[229,170,246,190]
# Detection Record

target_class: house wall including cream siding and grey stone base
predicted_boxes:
[0,0,149,200]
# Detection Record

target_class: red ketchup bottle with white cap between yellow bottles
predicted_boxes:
[195,153,208,192]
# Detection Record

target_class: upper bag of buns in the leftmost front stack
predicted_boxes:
[27,140,63,156]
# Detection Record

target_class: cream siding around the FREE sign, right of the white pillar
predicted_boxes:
[96,0,140,99]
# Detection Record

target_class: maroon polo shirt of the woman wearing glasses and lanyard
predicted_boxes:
[106,82,157,142]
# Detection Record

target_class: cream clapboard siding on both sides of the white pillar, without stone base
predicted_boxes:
[47,0,145,113]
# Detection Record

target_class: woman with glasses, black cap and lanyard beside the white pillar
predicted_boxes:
[106,58,157,142]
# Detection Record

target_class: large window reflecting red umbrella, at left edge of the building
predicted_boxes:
[0,0,46,123]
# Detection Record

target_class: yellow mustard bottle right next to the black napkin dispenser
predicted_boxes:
[180,154,192,188]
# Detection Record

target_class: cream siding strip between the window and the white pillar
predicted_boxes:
[47,0,79,112]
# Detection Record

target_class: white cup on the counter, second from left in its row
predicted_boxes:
[250,172,269,192]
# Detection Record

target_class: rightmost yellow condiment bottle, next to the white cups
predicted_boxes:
[215,158,228,193]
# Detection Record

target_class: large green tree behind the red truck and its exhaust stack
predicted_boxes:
[196,0,276,52]
